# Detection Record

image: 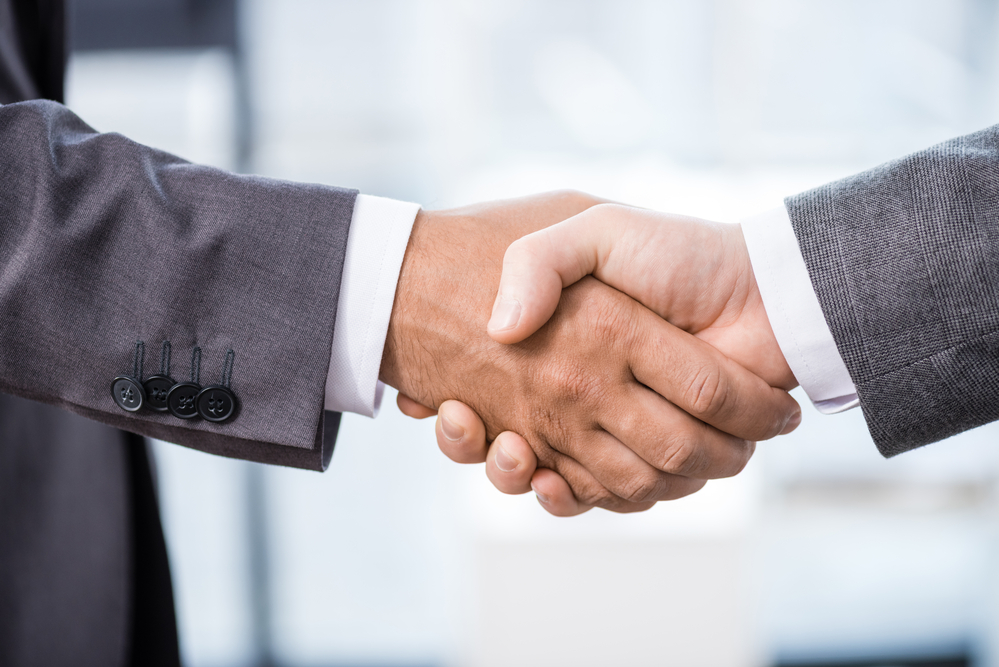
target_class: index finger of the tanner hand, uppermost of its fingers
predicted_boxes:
[630,311,801,441]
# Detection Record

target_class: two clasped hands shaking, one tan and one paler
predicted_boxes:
[380,192,801,516]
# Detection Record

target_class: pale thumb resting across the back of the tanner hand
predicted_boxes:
[487,204,611,345]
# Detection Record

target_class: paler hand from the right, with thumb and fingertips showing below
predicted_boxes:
[437,204,800,515]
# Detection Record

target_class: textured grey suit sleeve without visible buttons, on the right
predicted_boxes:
[785,125,999,456]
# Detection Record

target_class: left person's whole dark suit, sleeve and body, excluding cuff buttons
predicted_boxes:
[0,0,356,667]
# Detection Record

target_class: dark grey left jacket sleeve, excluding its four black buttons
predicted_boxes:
[0,101,356,470]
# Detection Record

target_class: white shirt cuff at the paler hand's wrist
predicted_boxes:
[742,206,860,414]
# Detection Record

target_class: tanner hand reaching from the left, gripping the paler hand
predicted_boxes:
[381,193,800,511]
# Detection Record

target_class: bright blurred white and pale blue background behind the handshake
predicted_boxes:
[68,0,999,667]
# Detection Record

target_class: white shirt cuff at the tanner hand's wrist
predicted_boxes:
[324,195,420,417]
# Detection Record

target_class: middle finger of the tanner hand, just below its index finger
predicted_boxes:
[600,384,756,479]
